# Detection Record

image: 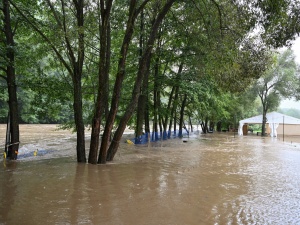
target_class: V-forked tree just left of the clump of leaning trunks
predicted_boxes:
[10,0,86,162]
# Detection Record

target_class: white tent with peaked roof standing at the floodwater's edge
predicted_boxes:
[238,112,300,137]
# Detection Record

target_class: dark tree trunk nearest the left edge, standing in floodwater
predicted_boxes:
[2,0,19,160]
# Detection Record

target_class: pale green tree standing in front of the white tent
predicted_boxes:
[251,49,298,136]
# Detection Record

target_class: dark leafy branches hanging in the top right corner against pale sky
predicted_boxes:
[236,0,300,48]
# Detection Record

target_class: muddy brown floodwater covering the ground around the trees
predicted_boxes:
[0,125,300,225]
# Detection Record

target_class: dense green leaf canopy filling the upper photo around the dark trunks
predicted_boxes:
[0,0,300,134]
